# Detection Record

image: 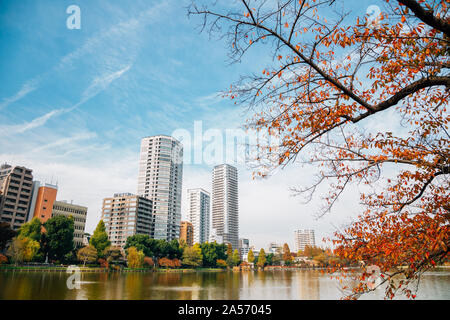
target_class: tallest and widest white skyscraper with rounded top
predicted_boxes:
[138,135,183,241]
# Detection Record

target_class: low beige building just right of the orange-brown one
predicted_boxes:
[52,201,87,247]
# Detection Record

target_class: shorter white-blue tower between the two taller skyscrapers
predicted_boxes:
[188,189,211,243]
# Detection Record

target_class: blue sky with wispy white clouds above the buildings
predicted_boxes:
[0,0,390,247]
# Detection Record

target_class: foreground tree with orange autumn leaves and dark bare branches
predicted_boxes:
[189,0,450,298]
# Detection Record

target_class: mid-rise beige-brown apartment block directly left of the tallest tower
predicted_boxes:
[101,193,153,247]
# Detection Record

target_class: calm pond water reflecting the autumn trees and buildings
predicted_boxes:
[0,269,450,300]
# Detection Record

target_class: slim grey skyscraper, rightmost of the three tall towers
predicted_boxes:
[212,164,239,249]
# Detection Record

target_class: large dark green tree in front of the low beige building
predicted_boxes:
[42,216,74,262]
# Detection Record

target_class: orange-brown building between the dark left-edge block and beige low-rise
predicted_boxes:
[31,183,58,223]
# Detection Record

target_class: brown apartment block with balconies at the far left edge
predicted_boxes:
[0,164,33,230]
